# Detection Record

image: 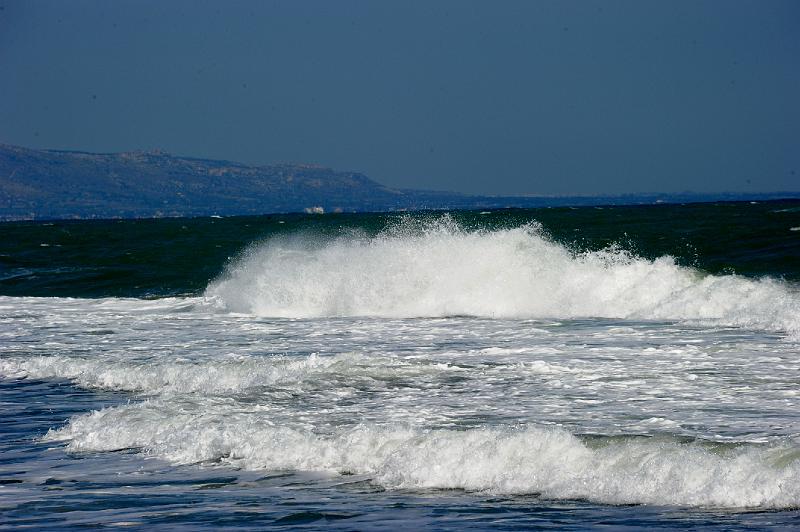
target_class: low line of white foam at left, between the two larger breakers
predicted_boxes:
[0,353,476,395]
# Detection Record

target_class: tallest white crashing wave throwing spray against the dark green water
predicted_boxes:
[206,216,800,332]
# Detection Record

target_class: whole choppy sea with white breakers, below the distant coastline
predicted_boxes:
[0,201,800,530]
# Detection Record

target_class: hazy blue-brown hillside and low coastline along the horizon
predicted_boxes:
[0,144,798,221]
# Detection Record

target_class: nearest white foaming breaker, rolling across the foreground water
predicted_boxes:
[46,408,800,508]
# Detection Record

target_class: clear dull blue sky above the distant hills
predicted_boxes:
[0,0,800,195]
